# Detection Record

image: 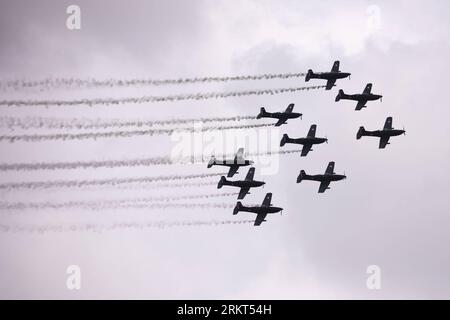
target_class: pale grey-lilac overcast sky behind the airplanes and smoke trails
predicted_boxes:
[0,0,450,299]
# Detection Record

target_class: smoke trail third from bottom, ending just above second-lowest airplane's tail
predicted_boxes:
[0,172,226,190]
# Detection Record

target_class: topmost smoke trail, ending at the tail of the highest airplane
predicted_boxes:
[0,73,306,90]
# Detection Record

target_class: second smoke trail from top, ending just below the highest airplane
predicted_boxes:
[0,86,326,107]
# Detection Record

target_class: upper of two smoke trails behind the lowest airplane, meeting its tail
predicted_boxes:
[0,201,234,211]
